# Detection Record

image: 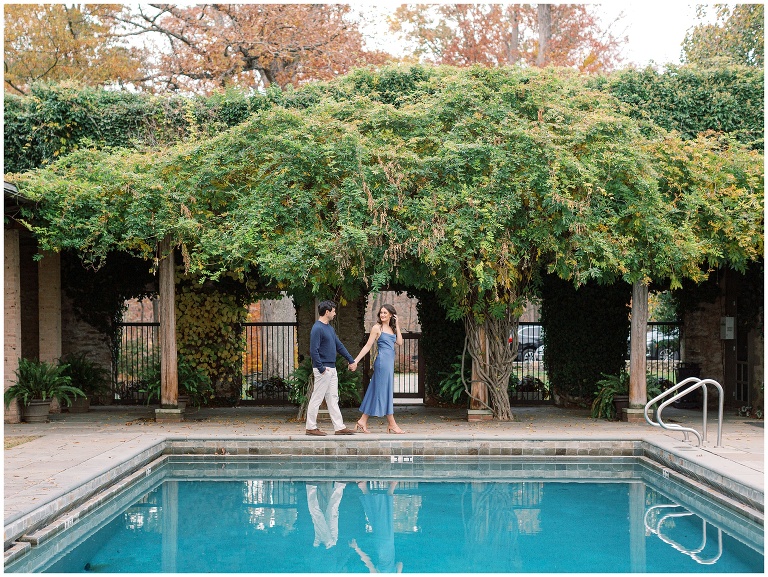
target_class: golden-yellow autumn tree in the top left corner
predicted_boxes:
[3,4,146,94]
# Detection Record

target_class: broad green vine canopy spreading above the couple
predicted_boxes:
[4,67,763,318]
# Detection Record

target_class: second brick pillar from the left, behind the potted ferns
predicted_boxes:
[37,251,61,413]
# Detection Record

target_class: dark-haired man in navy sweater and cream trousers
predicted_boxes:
[307,301,357,437]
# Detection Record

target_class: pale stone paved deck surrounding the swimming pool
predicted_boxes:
[3,405,765,537]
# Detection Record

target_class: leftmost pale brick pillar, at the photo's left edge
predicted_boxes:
[3,230,21,423]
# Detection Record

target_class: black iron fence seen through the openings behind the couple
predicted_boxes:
[113,322,688,404]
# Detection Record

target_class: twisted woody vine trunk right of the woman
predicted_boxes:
[464,308,518,421]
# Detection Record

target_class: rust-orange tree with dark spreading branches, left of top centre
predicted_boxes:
[114,4,387,93]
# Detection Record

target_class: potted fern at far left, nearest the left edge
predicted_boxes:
[5,358,85,423]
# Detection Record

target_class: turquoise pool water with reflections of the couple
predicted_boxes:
[6,458,764,573]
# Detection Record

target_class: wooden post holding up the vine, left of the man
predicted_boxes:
[159,237,179,408]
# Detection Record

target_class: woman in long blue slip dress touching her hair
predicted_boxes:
[355,305,404,434]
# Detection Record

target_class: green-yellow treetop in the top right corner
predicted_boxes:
[683,4,765,68]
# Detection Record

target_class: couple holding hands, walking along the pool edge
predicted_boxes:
[307,301,404,436]
